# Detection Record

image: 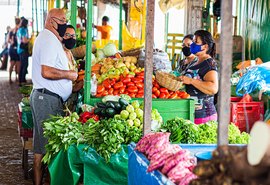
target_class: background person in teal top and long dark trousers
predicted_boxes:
[17,18,29,86]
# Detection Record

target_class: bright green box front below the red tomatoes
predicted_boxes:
[90,98,195,122]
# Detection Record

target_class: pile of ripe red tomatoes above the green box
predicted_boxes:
[96,71,190,99]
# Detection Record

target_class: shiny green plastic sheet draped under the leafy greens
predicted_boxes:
[48,145,128,185]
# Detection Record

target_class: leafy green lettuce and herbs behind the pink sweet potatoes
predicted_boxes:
[161,118,249,144]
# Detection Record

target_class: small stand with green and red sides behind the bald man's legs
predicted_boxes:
[18,102,33,179]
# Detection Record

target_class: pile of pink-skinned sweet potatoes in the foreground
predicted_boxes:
[135,132,197,185]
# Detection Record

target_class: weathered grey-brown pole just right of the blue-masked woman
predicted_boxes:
[218,0,232,145]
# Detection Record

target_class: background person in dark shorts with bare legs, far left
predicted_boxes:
[8,17,21,83]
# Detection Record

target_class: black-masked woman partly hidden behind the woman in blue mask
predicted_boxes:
[176,34,198,74]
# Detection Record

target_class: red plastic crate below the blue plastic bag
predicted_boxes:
[231,102,264,132]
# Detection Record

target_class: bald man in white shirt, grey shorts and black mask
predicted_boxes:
[30,9,77,185]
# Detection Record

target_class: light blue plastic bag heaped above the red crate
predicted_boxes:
[236,62,270,96]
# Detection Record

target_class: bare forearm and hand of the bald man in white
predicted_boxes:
[41,65,78,81]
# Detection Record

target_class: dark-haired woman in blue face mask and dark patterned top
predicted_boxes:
[179,30,218,124]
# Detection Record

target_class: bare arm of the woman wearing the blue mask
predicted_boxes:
[180,70,218,95]
